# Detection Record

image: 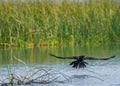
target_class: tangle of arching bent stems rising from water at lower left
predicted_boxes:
[0,57,71,86]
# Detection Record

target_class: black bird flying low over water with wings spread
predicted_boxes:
[49,54,115,68]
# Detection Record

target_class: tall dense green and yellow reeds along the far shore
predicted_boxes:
[0,0,120,47]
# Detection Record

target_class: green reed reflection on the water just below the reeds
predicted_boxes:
[0,44,120,66]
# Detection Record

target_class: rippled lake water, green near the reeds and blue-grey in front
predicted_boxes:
[0,44,120,86]
